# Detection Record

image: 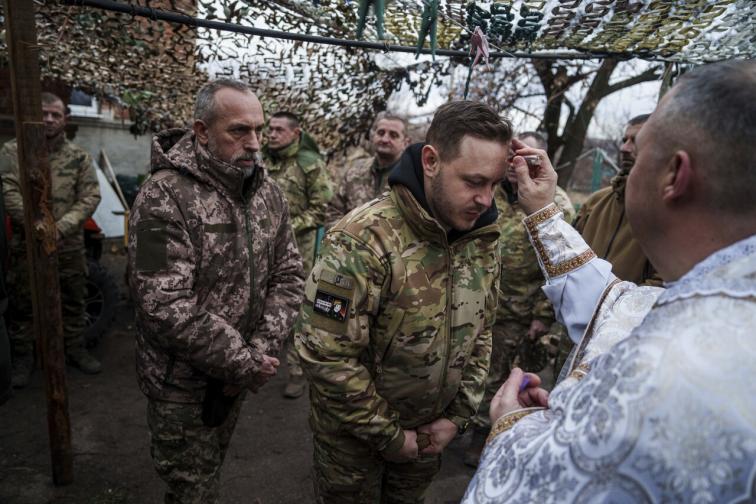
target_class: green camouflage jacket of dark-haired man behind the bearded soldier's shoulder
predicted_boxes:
[263,134,333,273]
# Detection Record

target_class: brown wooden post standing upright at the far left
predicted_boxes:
[4,0,73,485]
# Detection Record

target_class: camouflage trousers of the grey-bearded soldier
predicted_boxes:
[147,393,244,504]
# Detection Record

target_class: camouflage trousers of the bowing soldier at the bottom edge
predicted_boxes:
[313,432,441,504]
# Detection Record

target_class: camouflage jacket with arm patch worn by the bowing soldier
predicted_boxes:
[295,146,499,452]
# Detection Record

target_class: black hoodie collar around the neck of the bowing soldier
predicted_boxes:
[388,143,499,243]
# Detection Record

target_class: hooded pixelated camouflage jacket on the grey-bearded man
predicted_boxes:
[129,129,304,402]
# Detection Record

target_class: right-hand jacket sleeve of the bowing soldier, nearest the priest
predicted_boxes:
[444,261,501,433]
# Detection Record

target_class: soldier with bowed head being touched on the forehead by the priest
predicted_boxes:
[295,101,511,504]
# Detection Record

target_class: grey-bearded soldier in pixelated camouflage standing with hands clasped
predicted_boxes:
[129,79,304,504]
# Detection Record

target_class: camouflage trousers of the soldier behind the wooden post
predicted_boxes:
[7,249,87,355]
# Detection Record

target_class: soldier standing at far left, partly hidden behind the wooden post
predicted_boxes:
[0,93,102,388]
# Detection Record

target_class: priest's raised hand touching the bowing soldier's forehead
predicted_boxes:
[512,138,557,215]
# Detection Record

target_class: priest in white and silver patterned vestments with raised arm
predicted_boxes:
[464,60,756,503]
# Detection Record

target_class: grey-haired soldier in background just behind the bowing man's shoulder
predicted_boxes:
[326,112,410,226]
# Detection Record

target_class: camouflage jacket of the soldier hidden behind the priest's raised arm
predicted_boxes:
[496,185,575,327]
